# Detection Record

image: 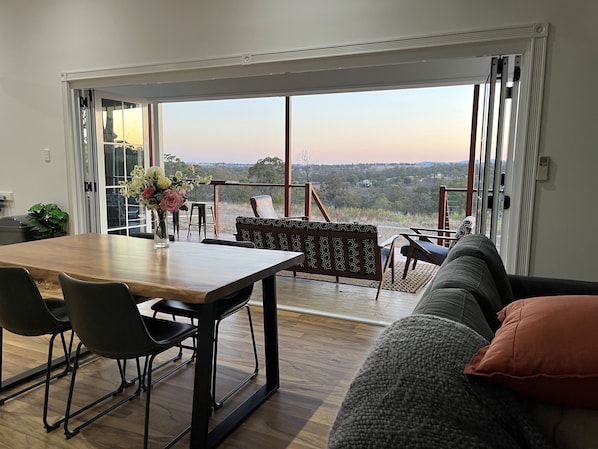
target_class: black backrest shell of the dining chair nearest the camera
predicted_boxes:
[59,274,157,359]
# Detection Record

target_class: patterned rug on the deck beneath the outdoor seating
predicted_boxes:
[278,260,439,293]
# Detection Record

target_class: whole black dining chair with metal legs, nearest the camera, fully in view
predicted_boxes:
[59,273,197,448]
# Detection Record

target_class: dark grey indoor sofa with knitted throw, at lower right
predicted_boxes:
[328,234,598,449]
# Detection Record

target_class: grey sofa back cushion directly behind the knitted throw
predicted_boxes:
[413,288,494,340]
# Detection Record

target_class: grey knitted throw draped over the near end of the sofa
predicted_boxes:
[328,315,551,449]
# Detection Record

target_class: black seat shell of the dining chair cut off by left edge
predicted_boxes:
[0,267,68,336]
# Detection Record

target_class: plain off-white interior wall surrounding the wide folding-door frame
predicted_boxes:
[0,0,598,280]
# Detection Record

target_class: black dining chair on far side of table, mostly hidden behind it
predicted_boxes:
[151,239,259,409]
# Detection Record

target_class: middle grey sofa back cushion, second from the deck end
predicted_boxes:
[421,256,507,332]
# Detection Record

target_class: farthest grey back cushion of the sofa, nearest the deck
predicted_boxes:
[446,234,514,304]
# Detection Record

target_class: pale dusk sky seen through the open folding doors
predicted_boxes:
[163,86,473,164]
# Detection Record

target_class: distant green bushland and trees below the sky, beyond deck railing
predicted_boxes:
[165,155,474,214]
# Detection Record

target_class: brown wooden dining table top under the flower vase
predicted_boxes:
[0,234,304,303]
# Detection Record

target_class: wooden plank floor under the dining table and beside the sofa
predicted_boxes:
[0,236,426,449]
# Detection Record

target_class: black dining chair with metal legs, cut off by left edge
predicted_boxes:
[0,267,73,432]
